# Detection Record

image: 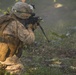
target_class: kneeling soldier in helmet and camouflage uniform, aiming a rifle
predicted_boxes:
[0,2,35,75]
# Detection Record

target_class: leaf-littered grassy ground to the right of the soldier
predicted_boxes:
[1,26,76,75]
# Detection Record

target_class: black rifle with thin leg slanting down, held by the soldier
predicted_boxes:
[25,14,49,42]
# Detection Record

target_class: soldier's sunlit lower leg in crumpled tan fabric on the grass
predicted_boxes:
[4,55,24,75]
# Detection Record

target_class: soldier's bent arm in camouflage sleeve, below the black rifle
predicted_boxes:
[18,21,35,44]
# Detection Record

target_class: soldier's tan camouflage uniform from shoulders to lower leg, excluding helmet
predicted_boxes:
[0,14,35,75]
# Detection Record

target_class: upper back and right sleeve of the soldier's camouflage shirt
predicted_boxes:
[4,21,35,44]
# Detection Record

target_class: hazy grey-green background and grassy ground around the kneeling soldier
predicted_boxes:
[0,0,76,75]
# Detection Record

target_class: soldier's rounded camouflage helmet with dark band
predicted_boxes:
[11,2,33,19]
